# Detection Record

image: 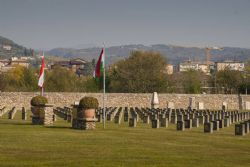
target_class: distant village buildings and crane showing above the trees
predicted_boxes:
[0,45,245,76]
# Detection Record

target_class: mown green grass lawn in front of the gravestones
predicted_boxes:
[0,113,250,167]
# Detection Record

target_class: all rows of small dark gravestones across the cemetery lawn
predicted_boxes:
[0,107,250,135]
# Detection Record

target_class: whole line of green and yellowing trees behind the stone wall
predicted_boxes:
[0,51,250,94]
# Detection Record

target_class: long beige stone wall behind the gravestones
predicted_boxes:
[0,92,250,109]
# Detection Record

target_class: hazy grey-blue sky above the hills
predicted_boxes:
[0,0,250,49]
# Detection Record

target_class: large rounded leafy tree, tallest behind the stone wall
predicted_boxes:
[109,51,167,93]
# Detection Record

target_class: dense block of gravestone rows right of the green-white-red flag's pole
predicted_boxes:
[94,107,250,135]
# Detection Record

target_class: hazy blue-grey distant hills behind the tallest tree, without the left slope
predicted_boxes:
[47,44,250,64]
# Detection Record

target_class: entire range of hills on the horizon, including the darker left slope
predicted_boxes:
[0,36,250,65]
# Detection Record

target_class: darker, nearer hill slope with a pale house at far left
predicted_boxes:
[0,36,33,59]
